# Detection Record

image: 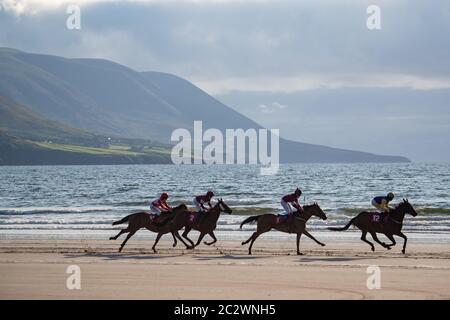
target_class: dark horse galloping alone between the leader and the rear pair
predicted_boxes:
[241,203,327,255]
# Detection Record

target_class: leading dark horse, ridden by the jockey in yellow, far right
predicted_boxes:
[328,199,417,254]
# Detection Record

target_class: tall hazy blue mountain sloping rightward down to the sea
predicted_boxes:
[0,48,409,162]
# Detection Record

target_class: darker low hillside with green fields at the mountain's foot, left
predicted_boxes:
[0,96,170,165]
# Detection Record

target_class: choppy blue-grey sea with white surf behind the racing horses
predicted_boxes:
[0,163,450,244]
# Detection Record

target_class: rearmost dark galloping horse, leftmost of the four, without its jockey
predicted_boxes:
[109,204,190,252]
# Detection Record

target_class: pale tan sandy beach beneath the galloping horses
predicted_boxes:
[0,240,450,300]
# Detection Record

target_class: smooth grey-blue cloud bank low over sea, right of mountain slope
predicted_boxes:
[217,88,450,161]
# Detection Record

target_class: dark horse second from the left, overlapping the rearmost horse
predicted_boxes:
[178,199,233,249]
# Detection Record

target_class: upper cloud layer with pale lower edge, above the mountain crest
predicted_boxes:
[0,0,450,94]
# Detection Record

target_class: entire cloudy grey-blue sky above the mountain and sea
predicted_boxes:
[0,0,450,161]
